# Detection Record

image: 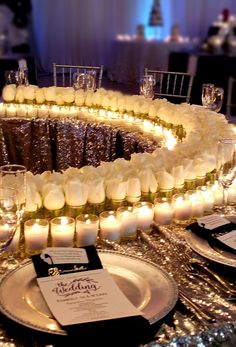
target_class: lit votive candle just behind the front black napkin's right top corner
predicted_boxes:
[75,214,99,247]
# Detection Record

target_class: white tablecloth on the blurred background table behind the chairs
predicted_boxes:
[108,40,196,83]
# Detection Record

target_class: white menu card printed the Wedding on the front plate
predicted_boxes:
[37,269,142,325]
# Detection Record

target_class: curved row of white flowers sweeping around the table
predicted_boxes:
[3,85,236,211]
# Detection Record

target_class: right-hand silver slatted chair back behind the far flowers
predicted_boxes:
[144,68,193,103]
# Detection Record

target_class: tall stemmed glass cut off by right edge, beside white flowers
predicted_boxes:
[216,138,236,214]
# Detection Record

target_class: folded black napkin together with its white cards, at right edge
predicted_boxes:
[186,215,236,253]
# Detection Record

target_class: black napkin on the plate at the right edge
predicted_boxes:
[186,222,236,253]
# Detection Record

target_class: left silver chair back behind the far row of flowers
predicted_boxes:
[52,63,104,88]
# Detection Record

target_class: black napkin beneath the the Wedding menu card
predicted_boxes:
[31,246,154,347]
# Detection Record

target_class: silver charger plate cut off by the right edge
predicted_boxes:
[185,231,236,267]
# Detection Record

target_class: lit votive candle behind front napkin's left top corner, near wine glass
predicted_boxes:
[24,219,49,253]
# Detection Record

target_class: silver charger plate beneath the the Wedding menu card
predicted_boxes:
[0,251,178,335]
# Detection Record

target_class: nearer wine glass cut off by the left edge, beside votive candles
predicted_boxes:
[0,186,19,270]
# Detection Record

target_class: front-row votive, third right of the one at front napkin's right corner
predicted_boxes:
[133,201,154,232]
